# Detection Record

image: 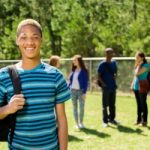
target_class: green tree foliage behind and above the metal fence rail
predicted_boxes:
[0,0,150,59]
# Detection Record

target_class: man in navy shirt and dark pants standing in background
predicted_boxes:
[97,48,118,127]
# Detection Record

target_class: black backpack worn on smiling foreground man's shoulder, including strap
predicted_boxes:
[0,65,21,144]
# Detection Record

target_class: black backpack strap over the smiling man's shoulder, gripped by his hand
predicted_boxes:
[8,65,21,144]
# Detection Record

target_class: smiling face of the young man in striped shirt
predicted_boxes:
[16,25,42,60]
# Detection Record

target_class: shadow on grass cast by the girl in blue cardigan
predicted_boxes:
[81,128,110,138]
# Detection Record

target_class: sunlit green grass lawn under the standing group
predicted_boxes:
[0,93,150,150]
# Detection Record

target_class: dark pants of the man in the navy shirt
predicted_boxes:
[102,89,116,123]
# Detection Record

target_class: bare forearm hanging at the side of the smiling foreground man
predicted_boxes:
[56,103,68,150]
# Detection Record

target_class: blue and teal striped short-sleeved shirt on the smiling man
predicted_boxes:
[0,63,70,150]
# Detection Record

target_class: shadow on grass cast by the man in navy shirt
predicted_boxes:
[117,125,147,136]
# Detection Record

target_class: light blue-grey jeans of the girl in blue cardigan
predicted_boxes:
[71,89,85,124]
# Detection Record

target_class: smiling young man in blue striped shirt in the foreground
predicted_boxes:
[0,19,70,150]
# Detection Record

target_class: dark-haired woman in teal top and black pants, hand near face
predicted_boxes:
[131,52,150,126]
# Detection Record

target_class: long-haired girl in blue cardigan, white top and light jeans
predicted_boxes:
[69,55,89,128]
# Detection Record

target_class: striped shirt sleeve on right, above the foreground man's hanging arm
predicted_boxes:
[56,71,70,104]
